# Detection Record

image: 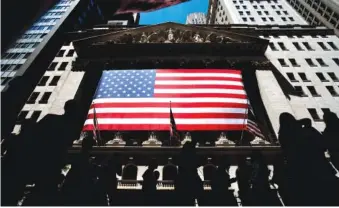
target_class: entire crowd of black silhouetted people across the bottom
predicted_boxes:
[1,102,339,206]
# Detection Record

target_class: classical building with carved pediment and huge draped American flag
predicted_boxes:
[7,22,339,206]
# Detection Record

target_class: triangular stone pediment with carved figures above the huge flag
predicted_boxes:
[74,22,265,46]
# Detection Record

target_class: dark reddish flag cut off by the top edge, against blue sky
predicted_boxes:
[112,0,189,14]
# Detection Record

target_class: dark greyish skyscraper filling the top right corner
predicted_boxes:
[287,0,339,36]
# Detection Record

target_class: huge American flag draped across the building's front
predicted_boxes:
[84,69,248,131]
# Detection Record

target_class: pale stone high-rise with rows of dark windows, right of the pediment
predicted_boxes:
[208,0,339,134]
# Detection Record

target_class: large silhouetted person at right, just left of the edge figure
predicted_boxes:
[279,113,335,206]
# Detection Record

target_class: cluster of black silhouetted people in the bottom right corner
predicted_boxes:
[274,112,339,206]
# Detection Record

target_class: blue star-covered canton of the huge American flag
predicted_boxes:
[95,69,156,98]
